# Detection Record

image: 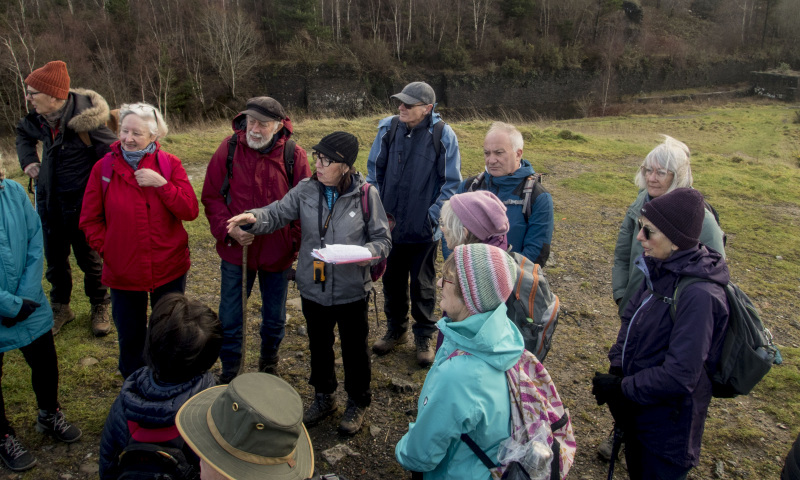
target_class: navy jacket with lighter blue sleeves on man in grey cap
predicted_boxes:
[367,113,461,243]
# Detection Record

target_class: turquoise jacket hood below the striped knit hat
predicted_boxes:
[437,304,525,371]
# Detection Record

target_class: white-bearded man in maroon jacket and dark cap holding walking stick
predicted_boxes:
[201,97,311,384]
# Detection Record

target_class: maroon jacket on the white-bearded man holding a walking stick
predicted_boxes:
[201,114,311,272]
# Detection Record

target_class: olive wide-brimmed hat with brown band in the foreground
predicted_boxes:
[175,373,314,480]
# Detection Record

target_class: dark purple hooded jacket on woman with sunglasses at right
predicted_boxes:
[608,245,730,467]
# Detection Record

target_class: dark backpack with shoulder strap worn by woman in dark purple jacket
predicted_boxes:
[650,277,780,398]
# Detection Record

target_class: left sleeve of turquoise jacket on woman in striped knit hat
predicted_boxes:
[394,361,478,473]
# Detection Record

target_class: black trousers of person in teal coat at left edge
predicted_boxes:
[0,327,58,437]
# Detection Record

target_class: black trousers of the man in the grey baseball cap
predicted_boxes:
[383,241,439,337]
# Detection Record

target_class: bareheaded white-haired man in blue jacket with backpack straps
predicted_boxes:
[457,122,553,267]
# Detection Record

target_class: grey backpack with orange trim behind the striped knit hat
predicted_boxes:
[506,253,559,362]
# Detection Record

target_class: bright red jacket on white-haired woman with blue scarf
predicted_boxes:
[80,141,199,291]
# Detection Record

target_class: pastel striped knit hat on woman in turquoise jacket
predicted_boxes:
[453,243,517,315]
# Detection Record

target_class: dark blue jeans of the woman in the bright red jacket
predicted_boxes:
[111,274,186,378]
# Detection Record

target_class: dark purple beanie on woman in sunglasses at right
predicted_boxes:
[641,188,706,250]
